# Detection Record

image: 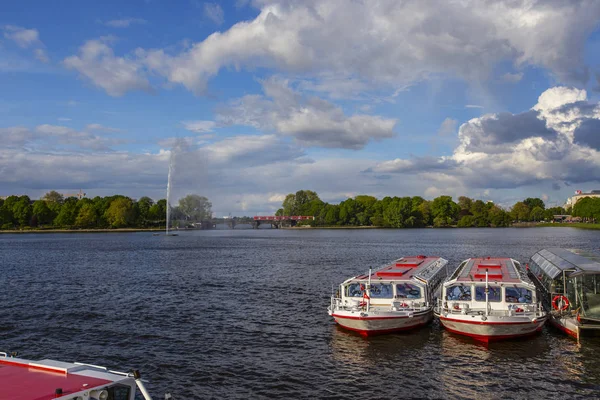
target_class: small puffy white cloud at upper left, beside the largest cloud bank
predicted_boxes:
[63,38,151,96]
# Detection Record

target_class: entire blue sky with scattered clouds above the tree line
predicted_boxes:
[0,0,600,216]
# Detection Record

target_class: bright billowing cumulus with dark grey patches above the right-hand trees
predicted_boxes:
[367,87,600,190]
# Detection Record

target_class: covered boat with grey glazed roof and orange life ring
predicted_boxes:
[529,248,600,339]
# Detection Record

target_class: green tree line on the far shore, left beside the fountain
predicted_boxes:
[0,191,212,229]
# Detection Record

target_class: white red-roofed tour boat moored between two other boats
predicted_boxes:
[435,257,547,342]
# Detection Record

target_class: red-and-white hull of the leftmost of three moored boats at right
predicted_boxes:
[332,310,433,337]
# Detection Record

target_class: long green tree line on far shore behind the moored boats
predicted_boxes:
[276,190,579,228]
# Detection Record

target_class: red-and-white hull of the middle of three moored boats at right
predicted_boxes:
[440,315,546,342]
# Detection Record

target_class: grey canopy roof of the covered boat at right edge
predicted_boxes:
[531,248,600,279]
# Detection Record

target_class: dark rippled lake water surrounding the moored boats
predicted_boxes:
[0,228,600,399]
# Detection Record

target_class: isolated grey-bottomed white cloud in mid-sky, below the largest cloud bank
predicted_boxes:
[217,78,397,149]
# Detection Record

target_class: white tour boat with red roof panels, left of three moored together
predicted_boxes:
[328,256,448,336]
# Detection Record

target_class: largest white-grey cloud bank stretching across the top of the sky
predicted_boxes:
[62,0,600,96]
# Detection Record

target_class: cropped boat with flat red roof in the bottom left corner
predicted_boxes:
[0,352,159,400]
